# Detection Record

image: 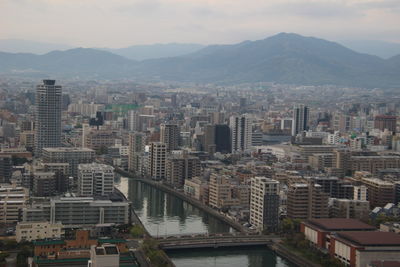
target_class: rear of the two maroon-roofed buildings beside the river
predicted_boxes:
[300,218,376,250]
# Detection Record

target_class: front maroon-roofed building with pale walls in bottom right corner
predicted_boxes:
[329,231,400,267]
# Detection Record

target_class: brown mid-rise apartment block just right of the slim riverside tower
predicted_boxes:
[166,151,201,188]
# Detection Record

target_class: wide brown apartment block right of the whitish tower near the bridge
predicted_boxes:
[287,183,329,220]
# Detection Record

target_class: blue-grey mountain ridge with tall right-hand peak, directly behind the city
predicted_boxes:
[0,33,400,87]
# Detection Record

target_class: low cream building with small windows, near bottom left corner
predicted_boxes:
[15,222,64,242]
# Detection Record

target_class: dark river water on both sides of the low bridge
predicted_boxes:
[117,178,294,267]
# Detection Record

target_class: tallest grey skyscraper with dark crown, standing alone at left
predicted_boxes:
[35,80,62,157]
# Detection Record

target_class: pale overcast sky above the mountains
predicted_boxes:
[0,0,400,47]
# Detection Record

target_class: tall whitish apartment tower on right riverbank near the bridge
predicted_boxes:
[250,177,279,232]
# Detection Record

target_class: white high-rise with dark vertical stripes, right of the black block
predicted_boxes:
[229,115,252,152]
